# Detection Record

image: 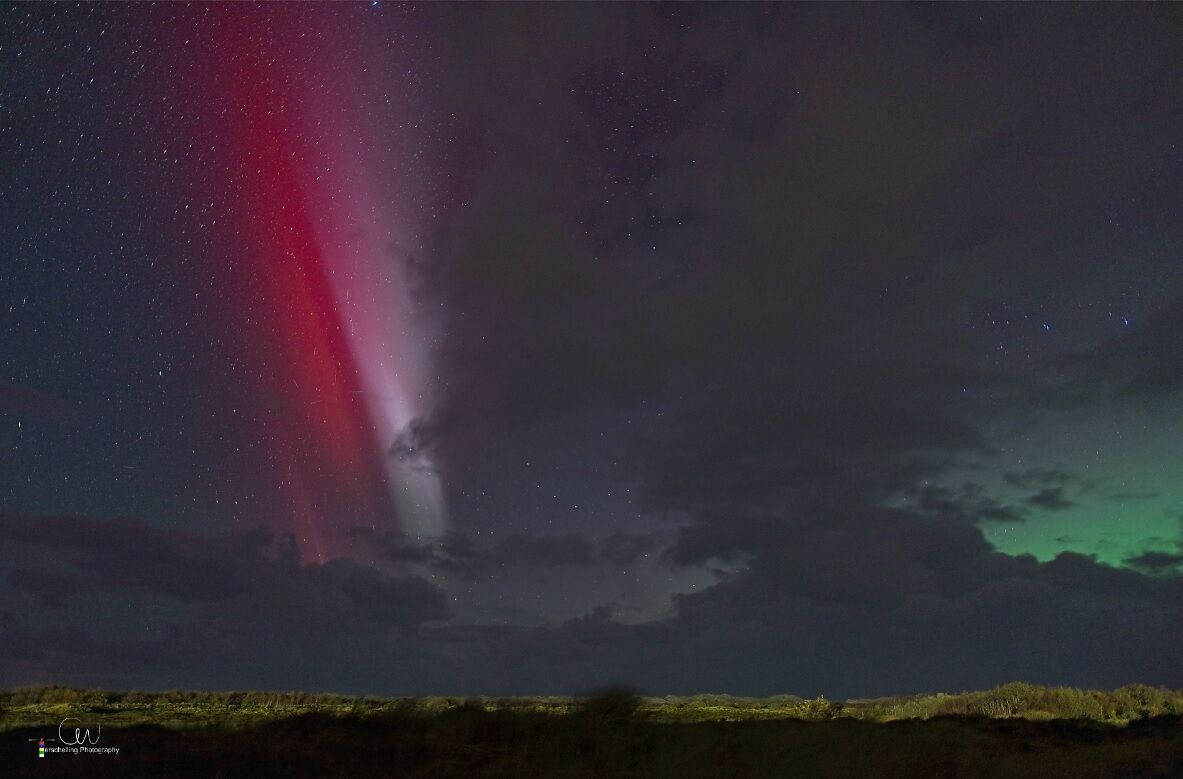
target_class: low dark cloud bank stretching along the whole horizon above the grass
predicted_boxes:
[0,509,1183,696]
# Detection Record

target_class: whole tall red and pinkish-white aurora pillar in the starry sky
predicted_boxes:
[181,7,444,562]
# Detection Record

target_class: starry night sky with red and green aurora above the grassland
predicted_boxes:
[0,2,1183,697]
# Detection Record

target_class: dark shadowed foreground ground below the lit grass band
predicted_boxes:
[0,707,1183,779]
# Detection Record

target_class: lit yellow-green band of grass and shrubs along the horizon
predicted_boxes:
[0,682,1183,729]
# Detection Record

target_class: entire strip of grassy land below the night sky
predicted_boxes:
[0,684,1183,778]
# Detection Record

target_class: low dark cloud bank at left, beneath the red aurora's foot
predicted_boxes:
[0,514,447,644]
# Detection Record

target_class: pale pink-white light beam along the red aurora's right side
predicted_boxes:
[288,24,446,537]
